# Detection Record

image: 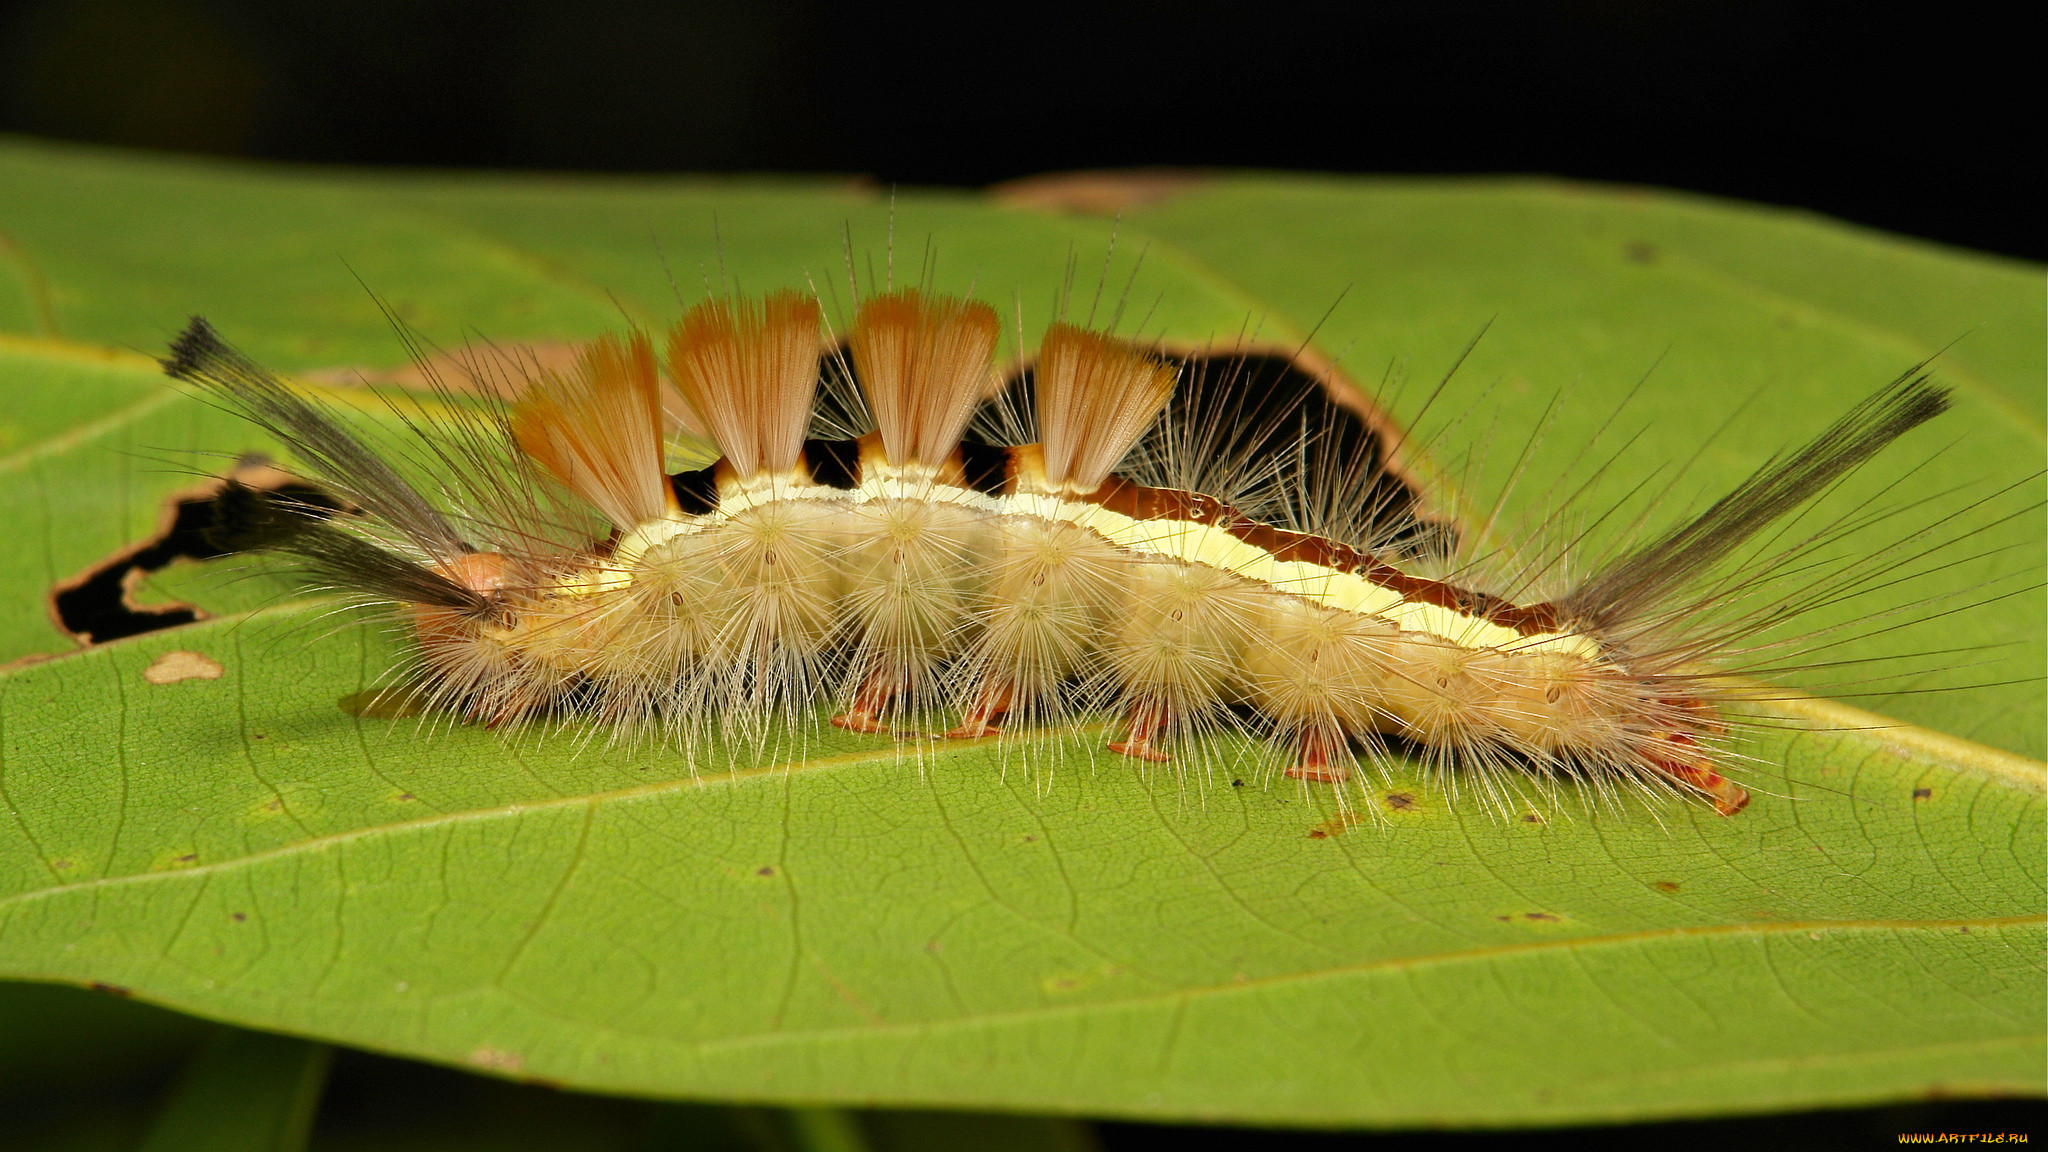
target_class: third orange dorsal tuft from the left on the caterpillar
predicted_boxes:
[850,289,997,467]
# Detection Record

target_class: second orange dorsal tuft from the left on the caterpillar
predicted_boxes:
[668,291,821,480]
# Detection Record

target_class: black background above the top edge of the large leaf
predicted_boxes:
[0,0,2048,258]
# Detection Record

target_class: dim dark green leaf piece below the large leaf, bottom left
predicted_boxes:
[141,1029,334,1152]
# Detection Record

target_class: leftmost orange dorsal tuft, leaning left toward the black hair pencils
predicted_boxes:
[512,332,674,529]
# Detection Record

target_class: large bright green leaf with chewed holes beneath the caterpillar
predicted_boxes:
[0,136,2048,1125]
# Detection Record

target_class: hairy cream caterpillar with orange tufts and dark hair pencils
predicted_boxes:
[162,278,1948,816]
